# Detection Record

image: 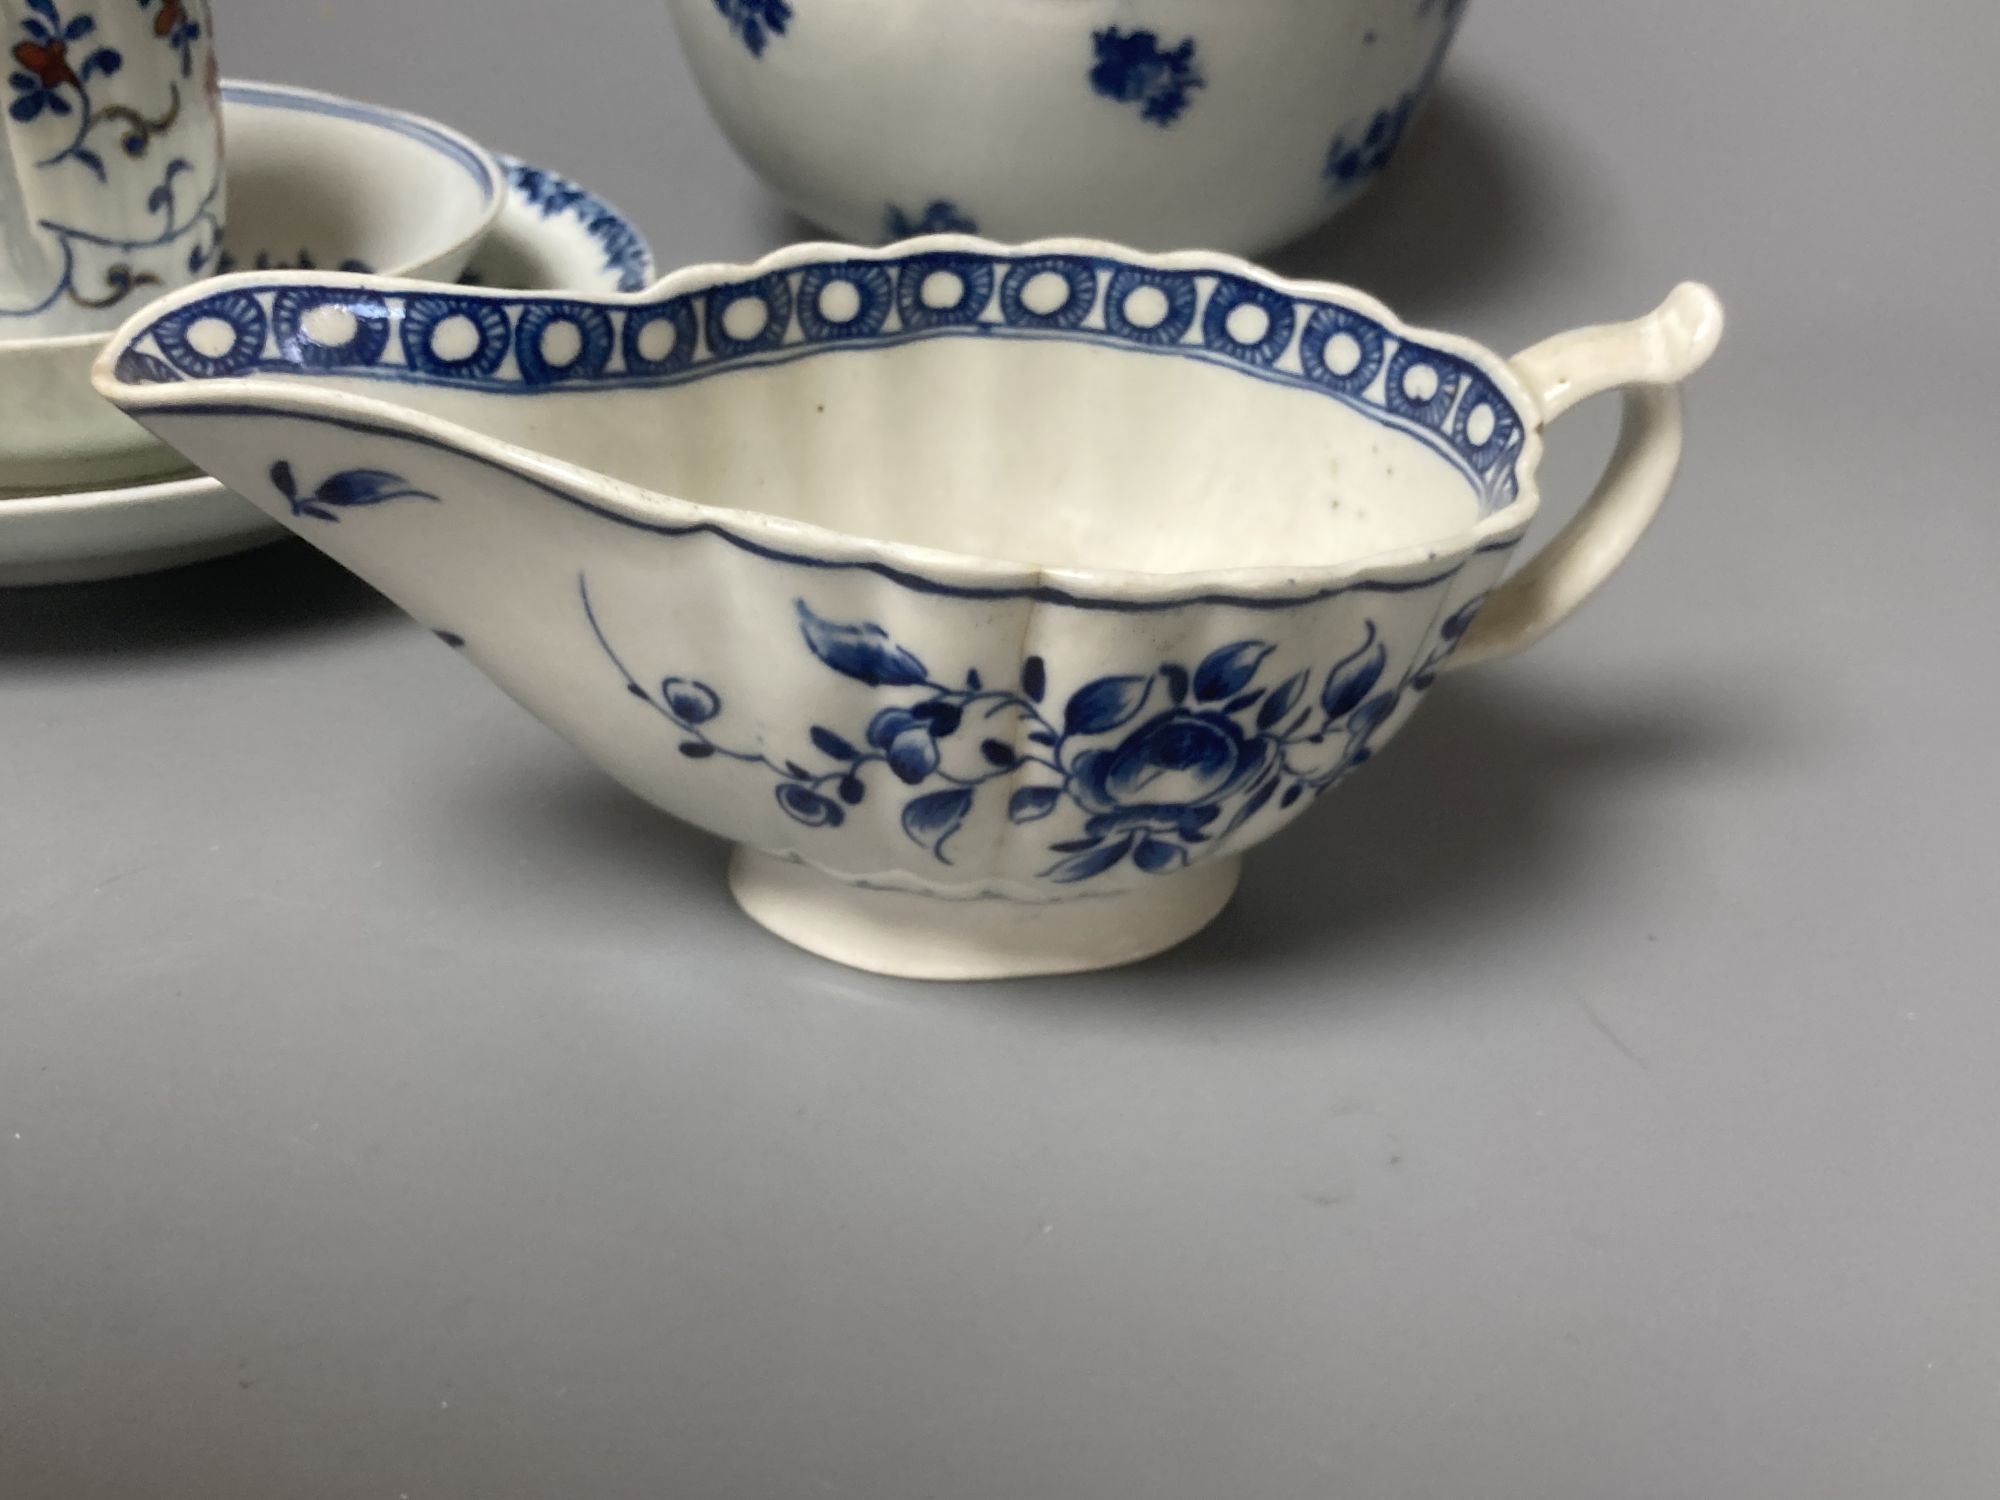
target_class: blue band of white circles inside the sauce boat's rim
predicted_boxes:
[126,248,1532,514]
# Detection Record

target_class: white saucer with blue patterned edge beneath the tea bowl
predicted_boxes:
[0,156,652,588]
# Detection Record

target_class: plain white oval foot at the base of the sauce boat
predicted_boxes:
[730,846,1242,980]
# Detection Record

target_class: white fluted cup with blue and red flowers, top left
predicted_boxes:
[0,0,228,342]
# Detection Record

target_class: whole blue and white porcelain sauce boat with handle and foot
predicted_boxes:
[96,236,1722,978]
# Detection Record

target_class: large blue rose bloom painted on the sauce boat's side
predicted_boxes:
[1070,708,1270,838]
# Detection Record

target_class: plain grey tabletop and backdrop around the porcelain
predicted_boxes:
[0,0,2000,1500]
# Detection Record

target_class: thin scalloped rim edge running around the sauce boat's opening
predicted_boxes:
[90,234,1544,602]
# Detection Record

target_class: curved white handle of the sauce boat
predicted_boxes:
[1446,282,1722,668]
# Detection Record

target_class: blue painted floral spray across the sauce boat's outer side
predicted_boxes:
[578,580,1478,884]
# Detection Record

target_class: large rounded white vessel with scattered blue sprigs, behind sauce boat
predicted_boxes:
[666,0,1462,254]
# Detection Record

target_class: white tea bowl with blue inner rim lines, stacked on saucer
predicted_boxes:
[0,82,506,494]
